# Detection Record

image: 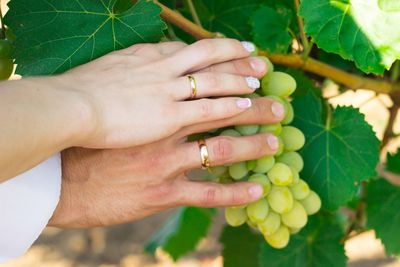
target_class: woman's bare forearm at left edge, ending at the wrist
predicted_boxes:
[0,77,90,182]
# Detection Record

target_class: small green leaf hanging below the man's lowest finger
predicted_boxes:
[145,207,215,260]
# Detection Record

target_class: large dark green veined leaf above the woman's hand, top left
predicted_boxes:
[5,0,165,76]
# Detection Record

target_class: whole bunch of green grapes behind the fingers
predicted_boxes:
[209,58,321,251]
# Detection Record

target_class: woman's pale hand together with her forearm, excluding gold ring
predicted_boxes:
[0,38,278,182]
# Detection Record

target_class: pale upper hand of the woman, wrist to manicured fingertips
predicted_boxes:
[58,39,266,148]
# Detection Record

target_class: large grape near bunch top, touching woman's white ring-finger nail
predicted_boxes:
[261,72,297,97]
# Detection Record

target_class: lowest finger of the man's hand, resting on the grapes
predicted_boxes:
[177,180,263,207]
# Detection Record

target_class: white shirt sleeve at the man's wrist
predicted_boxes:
[0,154,61,263]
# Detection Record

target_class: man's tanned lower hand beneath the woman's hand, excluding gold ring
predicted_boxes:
[49,98,282,228]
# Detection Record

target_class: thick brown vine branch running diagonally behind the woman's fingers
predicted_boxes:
[155,1,400,96]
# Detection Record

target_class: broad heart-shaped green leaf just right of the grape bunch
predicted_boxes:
[293,92,379,210]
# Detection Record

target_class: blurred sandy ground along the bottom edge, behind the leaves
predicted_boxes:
[0,213,400,267]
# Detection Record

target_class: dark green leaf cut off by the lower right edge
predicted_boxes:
[366,179,400,254]
